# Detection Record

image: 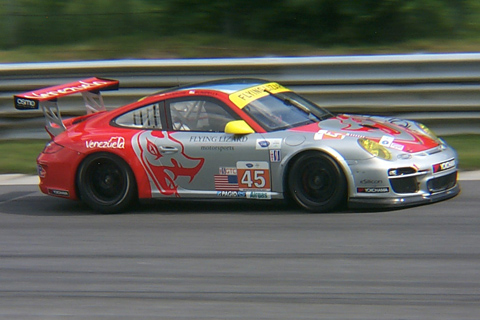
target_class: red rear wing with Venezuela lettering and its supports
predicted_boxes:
[13,77,119,136]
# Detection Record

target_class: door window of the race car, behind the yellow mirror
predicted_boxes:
[168,98,236,132]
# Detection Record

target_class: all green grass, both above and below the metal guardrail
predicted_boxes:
[0,34,480,174]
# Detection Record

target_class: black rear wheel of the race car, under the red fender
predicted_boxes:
[77,152,137,213]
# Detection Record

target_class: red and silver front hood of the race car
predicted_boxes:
[292,114,440,153]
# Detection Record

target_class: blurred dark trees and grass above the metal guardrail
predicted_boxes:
[0,0,480,62]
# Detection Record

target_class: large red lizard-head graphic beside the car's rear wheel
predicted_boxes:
[132,131,205,197]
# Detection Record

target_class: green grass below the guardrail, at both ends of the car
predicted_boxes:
[0,135,480,174]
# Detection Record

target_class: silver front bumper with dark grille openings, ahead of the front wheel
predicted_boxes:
[348,145,460,208]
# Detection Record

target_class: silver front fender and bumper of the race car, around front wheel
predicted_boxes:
[272,126,460,207]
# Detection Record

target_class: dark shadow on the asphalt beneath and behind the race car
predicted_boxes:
[0,184,450,216]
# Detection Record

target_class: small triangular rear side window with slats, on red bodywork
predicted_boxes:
[115,103,163,129]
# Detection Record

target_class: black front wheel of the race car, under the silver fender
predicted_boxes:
[288,152,347,213]
